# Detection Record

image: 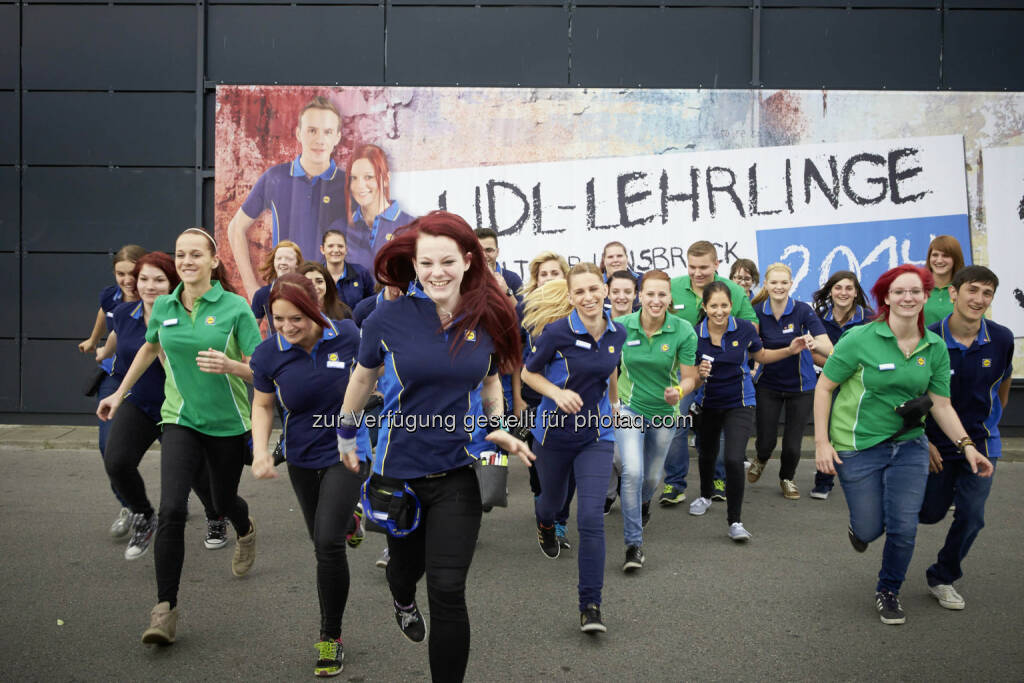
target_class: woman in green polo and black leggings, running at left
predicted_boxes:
[96,227,260,643]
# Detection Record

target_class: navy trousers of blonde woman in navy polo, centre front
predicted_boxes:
[534,441,613,610]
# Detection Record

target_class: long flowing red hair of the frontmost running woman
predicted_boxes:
[374,211,522,373]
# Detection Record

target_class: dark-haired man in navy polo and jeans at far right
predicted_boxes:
[920,265,1014,609]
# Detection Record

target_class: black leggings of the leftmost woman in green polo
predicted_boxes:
[154,425,251,608]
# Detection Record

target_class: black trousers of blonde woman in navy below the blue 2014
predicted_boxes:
[754,384,814,480]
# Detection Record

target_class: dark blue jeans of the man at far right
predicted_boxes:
[919,459,998,586]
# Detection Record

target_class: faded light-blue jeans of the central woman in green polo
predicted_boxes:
[615,407,676,546]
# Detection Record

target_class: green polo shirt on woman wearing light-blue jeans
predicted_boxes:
[615,310,697,419]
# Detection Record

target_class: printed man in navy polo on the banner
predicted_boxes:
[227,96,348,297]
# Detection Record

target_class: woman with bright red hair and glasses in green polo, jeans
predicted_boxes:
[814,264,992,624]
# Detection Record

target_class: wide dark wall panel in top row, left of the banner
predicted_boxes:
[22,5,197,90]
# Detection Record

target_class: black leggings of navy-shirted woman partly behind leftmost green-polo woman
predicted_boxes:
[103,400,219,519]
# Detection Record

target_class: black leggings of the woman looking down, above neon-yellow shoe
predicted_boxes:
[288,462,369,640]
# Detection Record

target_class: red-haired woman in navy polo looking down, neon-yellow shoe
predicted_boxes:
[249,273,370,676]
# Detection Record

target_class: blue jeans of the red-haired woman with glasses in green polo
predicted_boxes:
[836,435,928,593]
